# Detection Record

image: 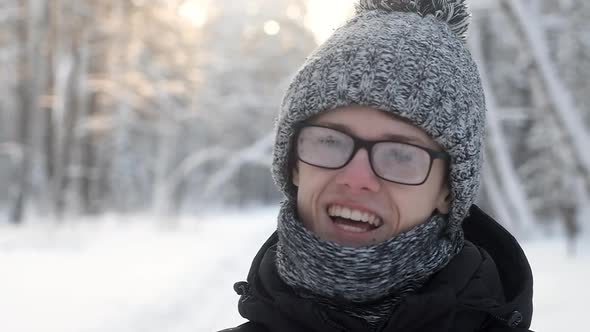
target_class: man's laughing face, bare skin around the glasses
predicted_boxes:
[293,106,450,247]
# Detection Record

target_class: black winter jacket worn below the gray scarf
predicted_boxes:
[224,205,533,332]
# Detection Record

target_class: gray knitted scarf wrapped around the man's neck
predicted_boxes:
[276,200,463,328]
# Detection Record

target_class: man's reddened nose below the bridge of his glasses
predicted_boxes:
[336,149,381,192]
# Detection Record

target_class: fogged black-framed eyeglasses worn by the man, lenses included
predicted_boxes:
[296,123,450,186]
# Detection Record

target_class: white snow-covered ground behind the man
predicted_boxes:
[0,208,590,332]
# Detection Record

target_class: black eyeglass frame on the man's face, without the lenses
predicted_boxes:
[293,122,451,186]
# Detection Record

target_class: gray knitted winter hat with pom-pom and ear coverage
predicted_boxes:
[272,0,485,236]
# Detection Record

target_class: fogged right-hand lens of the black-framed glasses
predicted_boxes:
[372,142,430,184]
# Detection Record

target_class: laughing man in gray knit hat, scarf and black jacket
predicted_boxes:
[223,0,532,332]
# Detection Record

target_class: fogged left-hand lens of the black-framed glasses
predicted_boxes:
[297,126,354,168]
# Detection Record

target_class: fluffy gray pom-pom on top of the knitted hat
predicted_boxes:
[355,0,471,41]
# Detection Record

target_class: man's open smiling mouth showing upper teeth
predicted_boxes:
[328,204,383,233]
